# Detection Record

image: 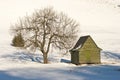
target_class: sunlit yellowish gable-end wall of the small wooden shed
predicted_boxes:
[79,37,100,63]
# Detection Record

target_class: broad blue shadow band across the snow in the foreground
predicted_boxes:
[0,65,120,80]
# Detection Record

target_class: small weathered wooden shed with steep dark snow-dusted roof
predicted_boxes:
[70,35,101,65]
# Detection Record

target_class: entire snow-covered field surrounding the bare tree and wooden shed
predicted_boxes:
[0,0,120,80]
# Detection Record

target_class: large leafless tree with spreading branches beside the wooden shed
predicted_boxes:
[11,8,79,63]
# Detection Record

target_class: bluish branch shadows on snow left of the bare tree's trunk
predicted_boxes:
[1,52,42,63]
